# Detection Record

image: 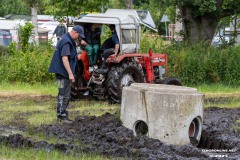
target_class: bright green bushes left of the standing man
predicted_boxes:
[0,46,54,84]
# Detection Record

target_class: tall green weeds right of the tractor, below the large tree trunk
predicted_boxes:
[167,44,240,85]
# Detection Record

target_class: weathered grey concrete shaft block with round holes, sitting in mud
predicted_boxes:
[121,83,204,145]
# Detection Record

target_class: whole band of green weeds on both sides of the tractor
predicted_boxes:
[0,30,240,85]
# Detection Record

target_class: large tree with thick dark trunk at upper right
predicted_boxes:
[169,0,240,44]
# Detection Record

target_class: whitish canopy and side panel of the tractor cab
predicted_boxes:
[74,9,157,54]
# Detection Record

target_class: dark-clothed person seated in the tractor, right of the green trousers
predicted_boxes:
[95,25,120,74]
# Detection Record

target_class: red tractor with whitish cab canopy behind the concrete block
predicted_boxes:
[72,9,182,103]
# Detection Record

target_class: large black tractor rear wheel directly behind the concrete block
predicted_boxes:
[106,62,144,103]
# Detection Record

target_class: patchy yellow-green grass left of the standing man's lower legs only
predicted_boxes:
[0,99,55,125]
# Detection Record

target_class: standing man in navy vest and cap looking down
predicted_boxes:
[48,26,86,122]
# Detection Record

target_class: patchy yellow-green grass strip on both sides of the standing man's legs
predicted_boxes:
[0,99,119,126]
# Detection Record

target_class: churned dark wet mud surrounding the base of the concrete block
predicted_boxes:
[0,94,240,160]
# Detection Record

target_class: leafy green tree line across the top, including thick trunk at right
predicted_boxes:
[0,0,240,44]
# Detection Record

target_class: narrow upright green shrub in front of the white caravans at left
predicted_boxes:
[19,22,34,52]
